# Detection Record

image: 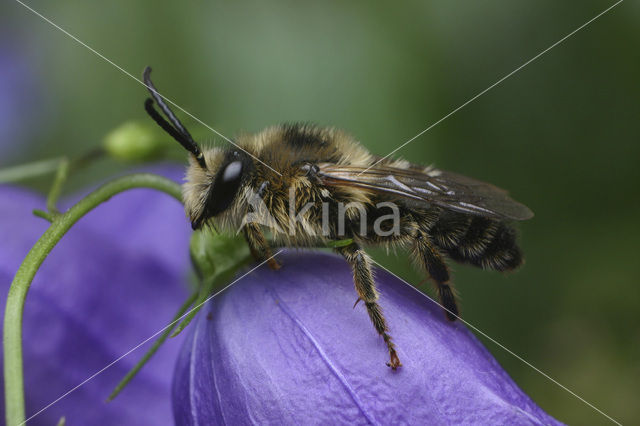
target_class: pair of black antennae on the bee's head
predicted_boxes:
[142,67,207,169]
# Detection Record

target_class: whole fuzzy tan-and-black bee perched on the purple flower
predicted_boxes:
[143,67,533,370]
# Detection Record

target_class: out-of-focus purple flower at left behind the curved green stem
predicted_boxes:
[0,168,190,425]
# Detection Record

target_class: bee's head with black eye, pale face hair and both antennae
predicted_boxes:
[143,67,253,229]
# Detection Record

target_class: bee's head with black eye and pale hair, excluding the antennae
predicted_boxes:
[183,148,253,229]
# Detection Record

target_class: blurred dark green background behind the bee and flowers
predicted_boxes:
[0,0,640,424]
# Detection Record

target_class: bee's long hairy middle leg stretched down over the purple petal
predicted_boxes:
[336,243,402,370]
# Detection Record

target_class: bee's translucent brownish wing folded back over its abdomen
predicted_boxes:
[318,163,533,220]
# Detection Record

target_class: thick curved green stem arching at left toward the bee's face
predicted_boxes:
[3,173,182,426]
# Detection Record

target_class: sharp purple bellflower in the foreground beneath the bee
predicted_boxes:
[173,253,558,425]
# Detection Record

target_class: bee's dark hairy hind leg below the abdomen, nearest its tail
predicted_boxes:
[413,231,460,321]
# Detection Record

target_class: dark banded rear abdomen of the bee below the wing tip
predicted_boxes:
[430,212,522,271]
